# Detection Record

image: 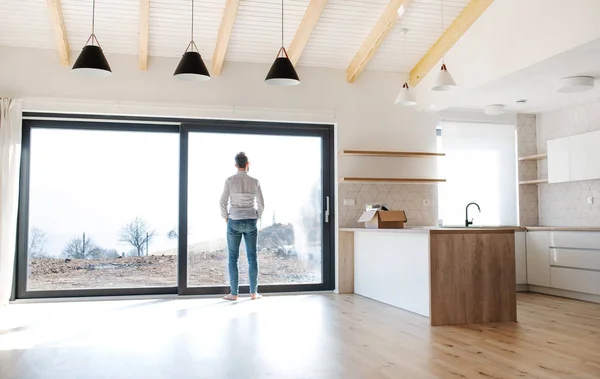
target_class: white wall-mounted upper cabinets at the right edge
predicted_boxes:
[547,131,600,183]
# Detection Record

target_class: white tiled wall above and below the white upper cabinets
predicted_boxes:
[537,99,600,226]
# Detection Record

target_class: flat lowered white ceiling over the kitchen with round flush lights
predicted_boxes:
[436,39,600,113]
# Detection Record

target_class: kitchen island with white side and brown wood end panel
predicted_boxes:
[338,227,517,325]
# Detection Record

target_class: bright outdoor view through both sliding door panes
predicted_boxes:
[27,128,323,291]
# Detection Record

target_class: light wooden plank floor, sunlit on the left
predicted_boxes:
[0,294,600,379]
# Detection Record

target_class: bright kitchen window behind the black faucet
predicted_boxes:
[438,122,518,225]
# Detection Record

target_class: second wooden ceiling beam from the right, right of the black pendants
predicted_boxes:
[346,0,411,83]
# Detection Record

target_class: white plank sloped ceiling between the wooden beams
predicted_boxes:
[0,0,469,72]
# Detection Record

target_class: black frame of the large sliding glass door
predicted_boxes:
[15,112,336,299]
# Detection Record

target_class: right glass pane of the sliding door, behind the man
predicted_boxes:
[188,133,323,286]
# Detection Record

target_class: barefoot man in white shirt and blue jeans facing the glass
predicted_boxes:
[221,153,265,301]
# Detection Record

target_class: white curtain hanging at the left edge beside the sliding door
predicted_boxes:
[0,98,22,306]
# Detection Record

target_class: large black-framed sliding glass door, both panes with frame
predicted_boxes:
[17,117,334,298]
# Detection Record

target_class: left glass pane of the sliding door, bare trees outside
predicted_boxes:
[27,128,179,290]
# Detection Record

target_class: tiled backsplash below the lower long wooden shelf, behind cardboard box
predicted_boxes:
[338,183,438,228]
